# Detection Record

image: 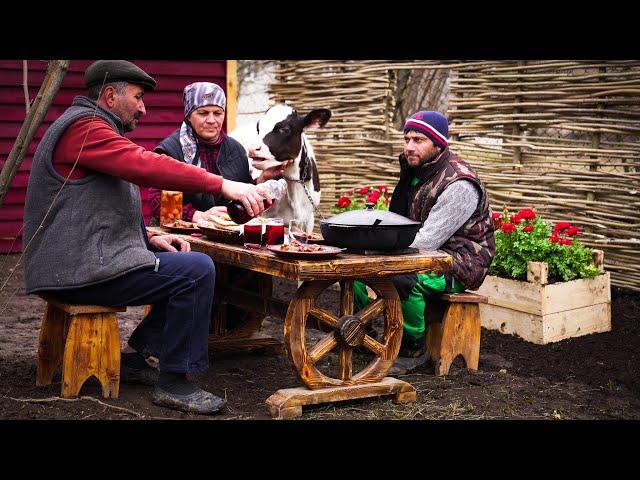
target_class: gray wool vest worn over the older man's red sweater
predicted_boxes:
[23,96,156,293]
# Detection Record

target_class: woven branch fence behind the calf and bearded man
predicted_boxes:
[269,61,640,291]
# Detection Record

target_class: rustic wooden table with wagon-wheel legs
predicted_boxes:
[147,227,451,418]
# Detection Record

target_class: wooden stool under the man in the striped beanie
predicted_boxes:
[425,292,487,375]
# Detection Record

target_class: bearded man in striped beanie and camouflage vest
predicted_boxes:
[356,111,495,375]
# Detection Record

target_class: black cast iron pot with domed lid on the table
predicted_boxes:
[320,204,421,250]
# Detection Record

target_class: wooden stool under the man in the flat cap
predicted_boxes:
[36,295,126,398]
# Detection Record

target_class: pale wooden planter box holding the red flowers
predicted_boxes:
[478,250,611,345]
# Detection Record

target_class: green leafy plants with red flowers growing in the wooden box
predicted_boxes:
[489,208,600,281]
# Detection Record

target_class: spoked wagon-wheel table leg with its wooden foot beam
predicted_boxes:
[266,278,416,418]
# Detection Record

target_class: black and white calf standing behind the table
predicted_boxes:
[230,105,331,232]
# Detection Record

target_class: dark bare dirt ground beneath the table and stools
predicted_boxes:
[0,255,640,420]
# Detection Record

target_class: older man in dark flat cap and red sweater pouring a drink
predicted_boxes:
[24,60,271,414]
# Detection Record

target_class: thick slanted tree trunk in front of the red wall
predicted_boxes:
[0,60,70,205]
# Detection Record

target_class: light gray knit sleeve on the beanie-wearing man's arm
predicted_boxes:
[411,180,480,250]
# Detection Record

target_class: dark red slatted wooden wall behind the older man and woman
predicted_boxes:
[0,60,227,252]
